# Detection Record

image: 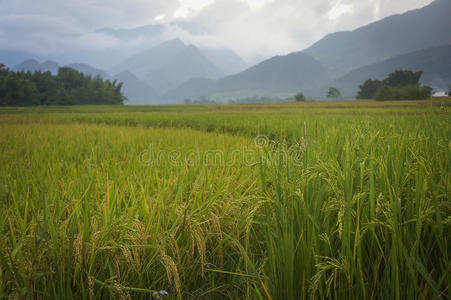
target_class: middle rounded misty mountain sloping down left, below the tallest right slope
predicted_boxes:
[165,52,327,101]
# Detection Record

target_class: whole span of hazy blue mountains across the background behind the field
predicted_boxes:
[0,0,451,104]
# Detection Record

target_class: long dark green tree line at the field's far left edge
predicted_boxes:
[0,67,126,106]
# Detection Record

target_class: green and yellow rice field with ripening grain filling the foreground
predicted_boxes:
[0,100,451,299]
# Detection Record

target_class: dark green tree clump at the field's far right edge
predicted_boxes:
[357,70,432,101]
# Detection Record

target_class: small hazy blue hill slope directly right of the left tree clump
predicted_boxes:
[114,71,160,104]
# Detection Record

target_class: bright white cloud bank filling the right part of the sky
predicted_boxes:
[173,0,432,60]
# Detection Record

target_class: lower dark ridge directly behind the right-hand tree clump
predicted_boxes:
[331,45,451,97]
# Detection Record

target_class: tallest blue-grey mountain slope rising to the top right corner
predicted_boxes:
[304,0,451,76]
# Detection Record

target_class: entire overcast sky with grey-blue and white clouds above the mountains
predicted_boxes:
[0,0,438,61]
